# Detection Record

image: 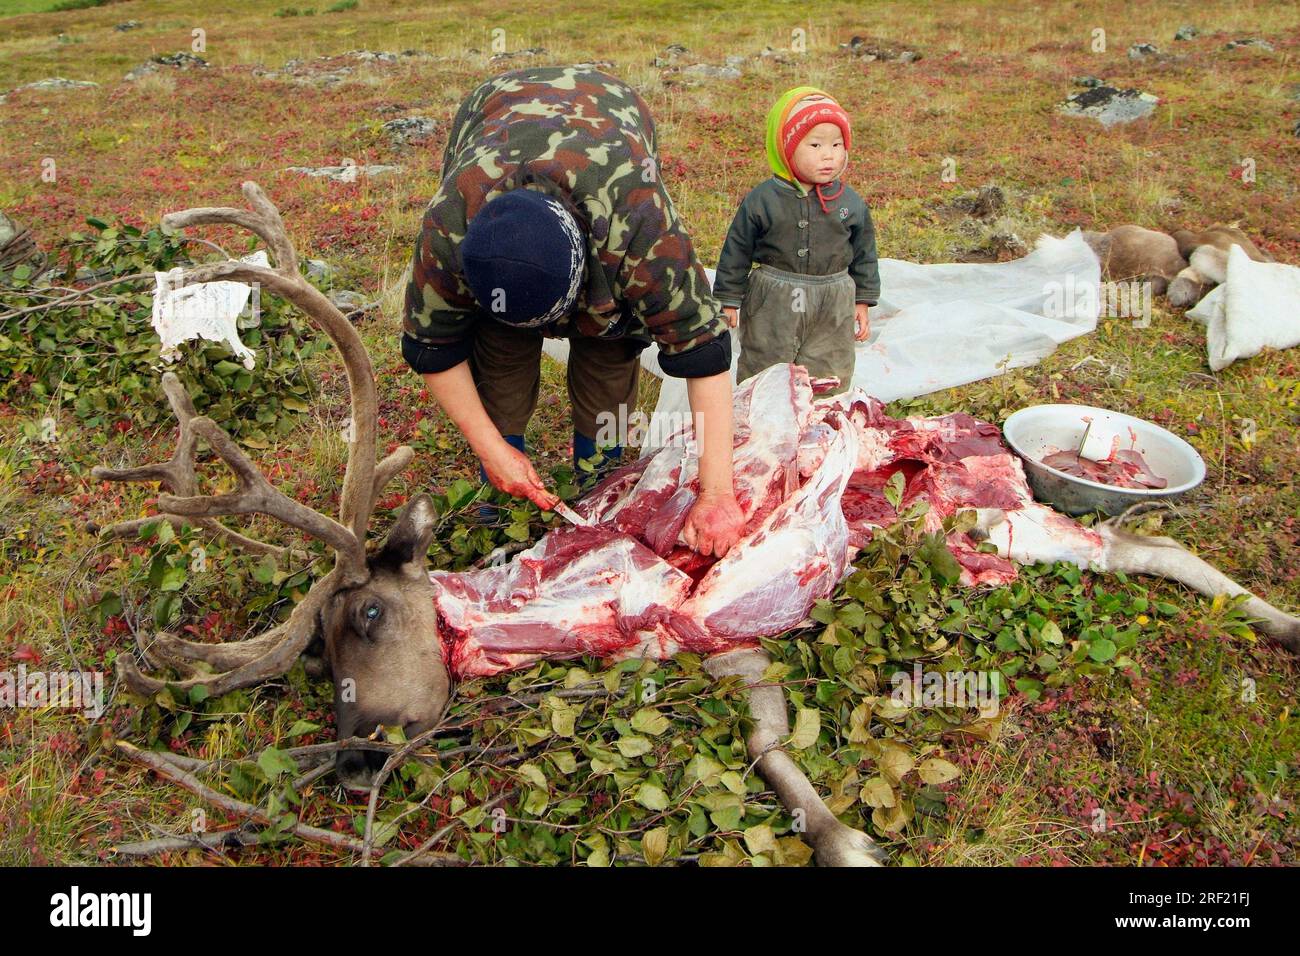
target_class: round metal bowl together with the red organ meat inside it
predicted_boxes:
[1002,405,1205,515]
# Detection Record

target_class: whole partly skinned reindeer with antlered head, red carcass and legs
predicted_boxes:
[104,183,1300,865]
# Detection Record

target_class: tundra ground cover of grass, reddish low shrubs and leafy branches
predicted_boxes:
[0,0,1300,865]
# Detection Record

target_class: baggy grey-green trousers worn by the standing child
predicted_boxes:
[736,264,857,394]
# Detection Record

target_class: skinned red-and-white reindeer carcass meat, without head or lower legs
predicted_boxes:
[430,365,1102,678]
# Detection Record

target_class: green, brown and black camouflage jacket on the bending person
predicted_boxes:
[403,66,731,377]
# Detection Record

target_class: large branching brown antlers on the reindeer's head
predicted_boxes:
[91,182,413,695]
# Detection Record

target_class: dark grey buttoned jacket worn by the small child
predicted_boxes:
[714,176,880,308]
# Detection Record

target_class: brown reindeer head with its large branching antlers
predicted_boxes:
[92,182,450,786]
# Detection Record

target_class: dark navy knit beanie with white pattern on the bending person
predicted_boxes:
[460,189,586,328]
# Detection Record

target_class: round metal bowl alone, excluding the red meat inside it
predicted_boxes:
[1002,405,1205,515]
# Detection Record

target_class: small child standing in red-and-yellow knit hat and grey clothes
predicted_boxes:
[714,86,880,392]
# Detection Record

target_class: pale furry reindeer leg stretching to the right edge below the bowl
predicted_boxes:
[1099,525,1300,654]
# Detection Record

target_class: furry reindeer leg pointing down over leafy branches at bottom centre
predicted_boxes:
[705,648,887,866]
